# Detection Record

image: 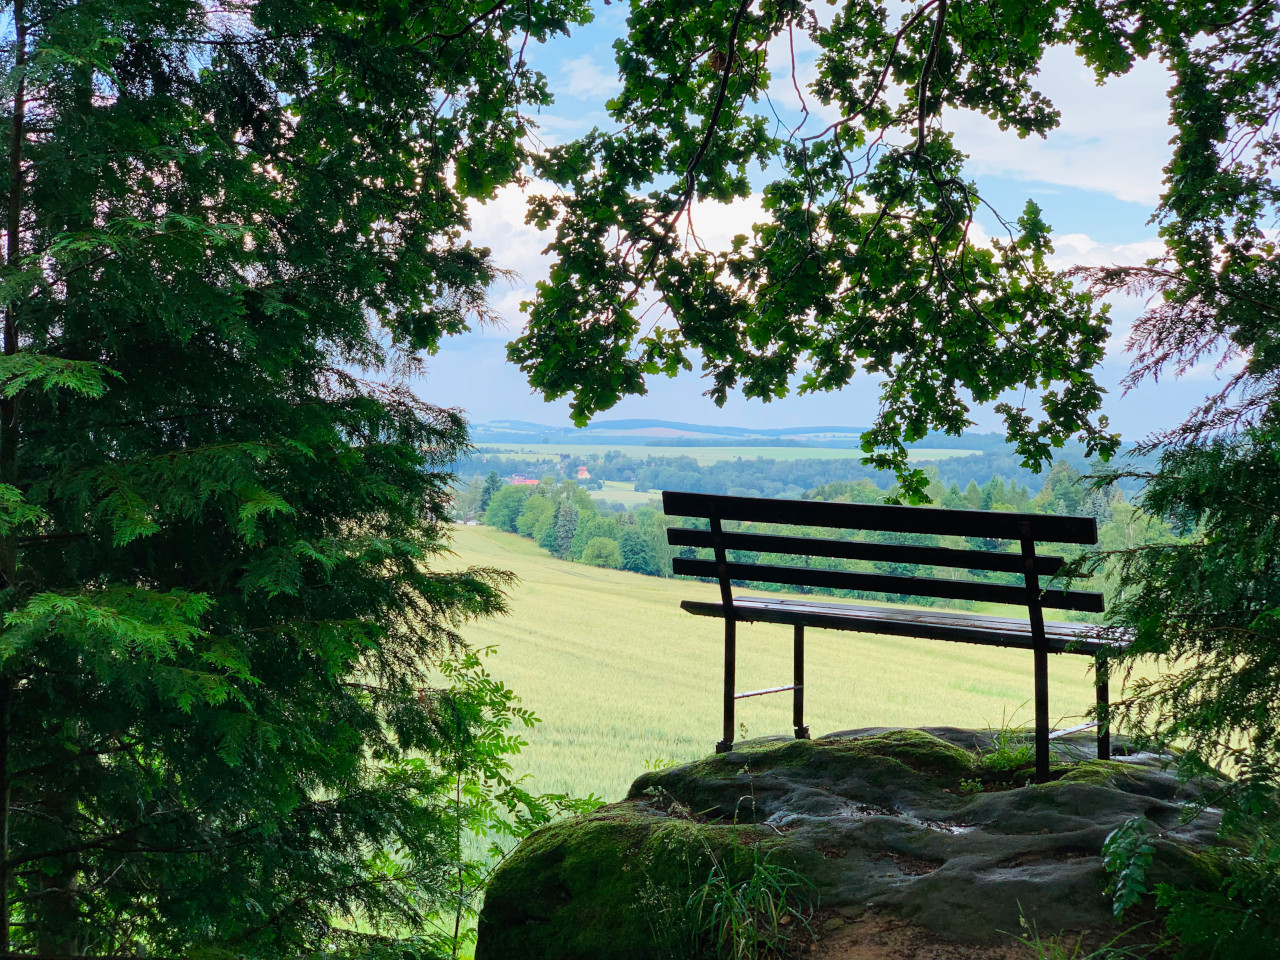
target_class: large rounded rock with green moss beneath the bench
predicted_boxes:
[476,728,1217,960]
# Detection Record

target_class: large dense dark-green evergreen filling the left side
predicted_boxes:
[0,0,584,957]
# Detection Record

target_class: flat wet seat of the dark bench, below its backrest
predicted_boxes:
[680,596,1117,654]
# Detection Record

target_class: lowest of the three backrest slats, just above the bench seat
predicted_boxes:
[671,557,1103,613]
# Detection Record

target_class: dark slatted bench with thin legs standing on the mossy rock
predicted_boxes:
[662,490,1115,781]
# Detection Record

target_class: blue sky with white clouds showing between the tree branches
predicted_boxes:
[417,4,1213,440]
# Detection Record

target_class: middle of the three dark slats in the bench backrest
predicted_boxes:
[667,526,1066,576]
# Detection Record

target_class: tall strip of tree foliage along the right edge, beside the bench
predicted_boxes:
[1059,7,1280,959]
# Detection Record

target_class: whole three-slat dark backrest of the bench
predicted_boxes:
[662,490,1103,613]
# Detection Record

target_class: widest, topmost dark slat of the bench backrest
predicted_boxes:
[662,490,1098,543]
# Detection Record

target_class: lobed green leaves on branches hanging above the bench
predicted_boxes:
[509,0,1266,493]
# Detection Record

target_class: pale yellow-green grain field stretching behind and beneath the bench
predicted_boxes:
[453,526,1093,800]
